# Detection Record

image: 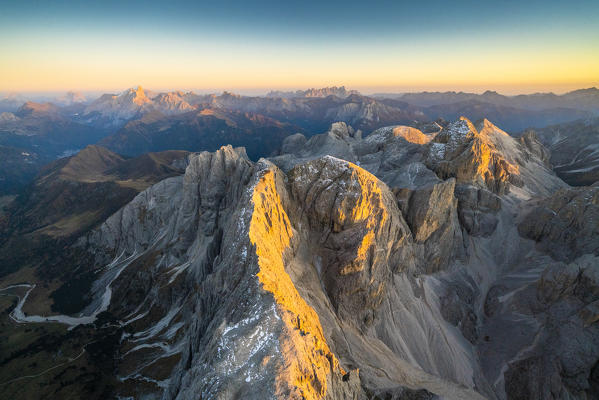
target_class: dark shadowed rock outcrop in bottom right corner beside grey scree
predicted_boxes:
[505,255,599,399]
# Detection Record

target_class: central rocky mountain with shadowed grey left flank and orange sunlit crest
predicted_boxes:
[81,147,363,399]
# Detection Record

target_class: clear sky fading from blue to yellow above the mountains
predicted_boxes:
[0,0,599,93]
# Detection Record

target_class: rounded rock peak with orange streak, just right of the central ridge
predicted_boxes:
[288,156,414,328]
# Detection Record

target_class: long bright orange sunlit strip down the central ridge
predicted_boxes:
[249,165,360,399]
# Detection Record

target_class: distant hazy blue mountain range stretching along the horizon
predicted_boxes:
[0,87,599,194]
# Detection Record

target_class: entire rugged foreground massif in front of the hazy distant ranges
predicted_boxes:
[0,108,599,399]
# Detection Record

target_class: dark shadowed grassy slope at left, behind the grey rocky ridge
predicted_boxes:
[0,146,187,274]
